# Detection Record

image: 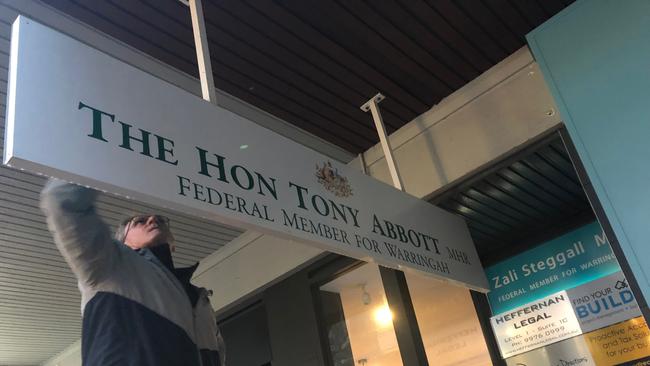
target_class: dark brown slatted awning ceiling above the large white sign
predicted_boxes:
[43,0,573,154]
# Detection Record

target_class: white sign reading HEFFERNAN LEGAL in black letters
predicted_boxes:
[490,291,582,358]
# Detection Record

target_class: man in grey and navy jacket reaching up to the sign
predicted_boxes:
[41,180,225,366]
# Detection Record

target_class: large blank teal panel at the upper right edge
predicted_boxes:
[527,0,650,314]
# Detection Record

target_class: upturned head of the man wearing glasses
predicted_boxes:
[124,215,171,249]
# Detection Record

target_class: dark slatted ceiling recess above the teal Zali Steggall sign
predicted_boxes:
[432,135,595,266]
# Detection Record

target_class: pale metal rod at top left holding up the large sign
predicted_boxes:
[189,0,217,104]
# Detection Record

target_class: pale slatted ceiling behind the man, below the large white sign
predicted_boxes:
[0,159,241,364]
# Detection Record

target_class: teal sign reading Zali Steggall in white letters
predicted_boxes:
[485,222,620,314]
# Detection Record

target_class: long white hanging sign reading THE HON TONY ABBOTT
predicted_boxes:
[4,17,487,291]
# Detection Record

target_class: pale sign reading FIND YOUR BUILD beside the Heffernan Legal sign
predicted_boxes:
[567,272,641,333]
